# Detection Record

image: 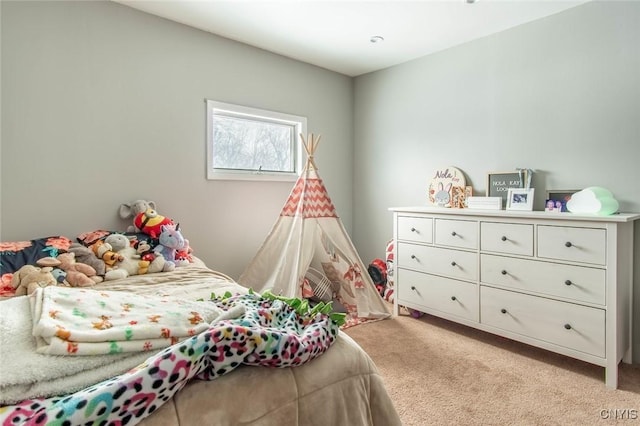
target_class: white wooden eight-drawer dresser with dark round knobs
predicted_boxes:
[391,207,640,388]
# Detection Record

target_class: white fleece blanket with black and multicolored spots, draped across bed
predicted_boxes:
[0,293,339,425]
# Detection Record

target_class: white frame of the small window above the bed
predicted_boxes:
[206,99,307,182]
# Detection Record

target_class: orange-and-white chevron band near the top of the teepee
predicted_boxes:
[280,177,338,219]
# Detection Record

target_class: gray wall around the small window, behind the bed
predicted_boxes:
[0,1,353,278]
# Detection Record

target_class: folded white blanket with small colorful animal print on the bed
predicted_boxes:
[29,286,222,356]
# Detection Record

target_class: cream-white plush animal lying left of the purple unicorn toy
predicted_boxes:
[104,234,166,281]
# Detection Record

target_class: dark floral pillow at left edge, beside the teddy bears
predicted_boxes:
[0,235,71,276]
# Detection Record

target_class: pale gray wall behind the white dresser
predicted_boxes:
[354,2,640,360]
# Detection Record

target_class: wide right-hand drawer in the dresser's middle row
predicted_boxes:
[480,254,606,306]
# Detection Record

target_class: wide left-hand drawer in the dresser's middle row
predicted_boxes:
[397,243,478,281]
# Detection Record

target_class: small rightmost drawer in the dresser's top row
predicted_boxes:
[538,225,607,265]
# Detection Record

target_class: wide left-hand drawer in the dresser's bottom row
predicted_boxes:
[397,268,478,321]
